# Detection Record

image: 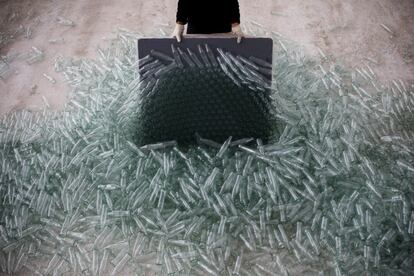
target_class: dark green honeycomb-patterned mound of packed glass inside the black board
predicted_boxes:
[137,67,271,145]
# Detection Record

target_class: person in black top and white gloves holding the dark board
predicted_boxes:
[172,0,244,43]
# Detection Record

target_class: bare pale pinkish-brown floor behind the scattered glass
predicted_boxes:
[0,0,414,115]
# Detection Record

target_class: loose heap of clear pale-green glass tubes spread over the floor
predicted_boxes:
[0,26,414,275]
